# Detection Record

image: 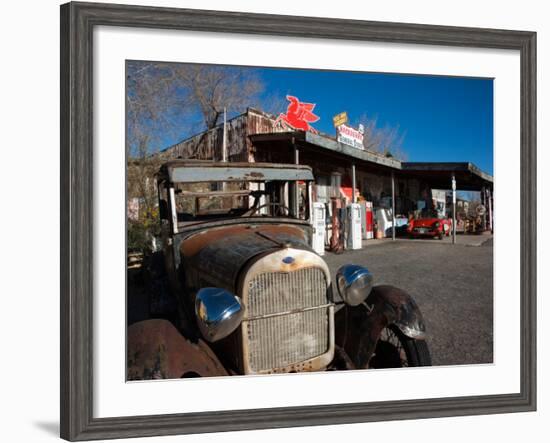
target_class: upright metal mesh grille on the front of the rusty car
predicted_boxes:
[246,268,329,372]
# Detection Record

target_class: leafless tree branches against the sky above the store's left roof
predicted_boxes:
[127,62,263,156]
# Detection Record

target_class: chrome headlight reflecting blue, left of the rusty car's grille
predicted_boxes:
[195,288,244,342]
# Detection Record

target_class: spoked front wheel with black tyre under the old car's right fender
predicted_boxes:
[369,325,432,369]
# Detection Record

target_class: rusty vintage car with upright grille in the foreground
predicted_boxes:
[128,160,431,378]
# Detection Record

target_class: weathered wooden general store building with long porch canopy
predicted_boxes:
[158,108,493,225]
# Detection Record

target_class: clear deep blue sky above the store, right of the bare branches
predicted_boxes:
[255,68,493,174]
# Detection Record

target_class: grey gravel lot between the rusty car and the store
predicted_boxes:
[324,239,493,365]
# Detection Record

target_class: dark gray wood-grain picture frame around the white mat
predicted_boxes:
[60,3,536,441]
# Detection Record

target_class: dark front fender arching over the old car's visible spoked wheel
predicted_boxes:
[336,285,426,369]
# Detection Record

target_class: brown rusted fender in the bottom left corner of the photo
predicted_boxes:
[126,319,230,381]
